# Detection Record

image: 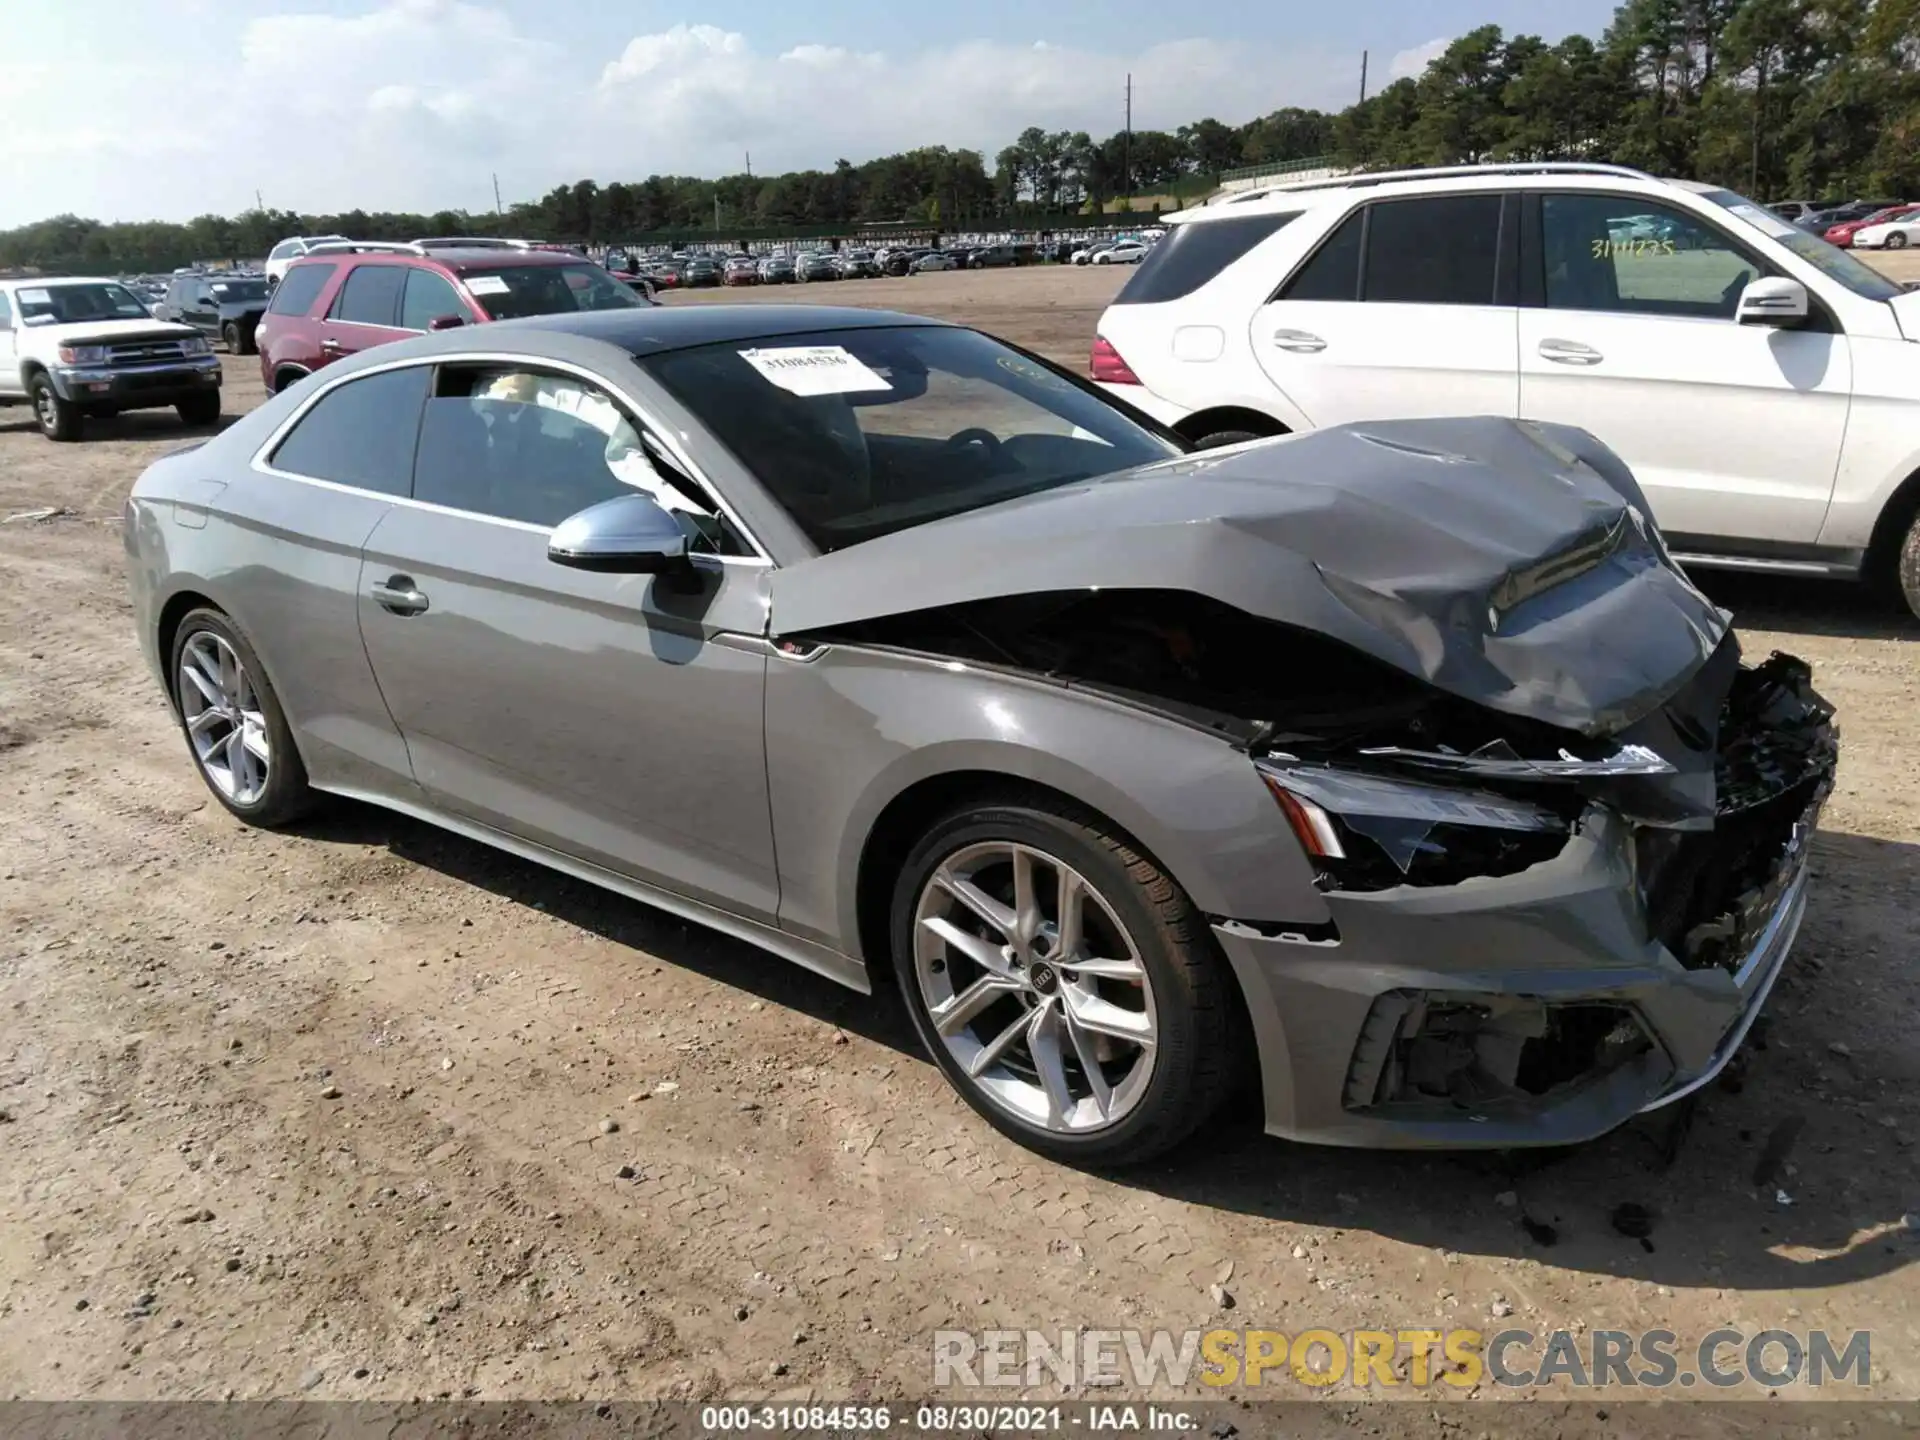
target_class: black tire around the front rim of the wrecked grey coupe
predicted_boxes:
[889,797,1244,1167]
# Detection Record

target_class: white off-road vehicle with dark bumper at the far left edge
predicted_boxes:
[0,278,221,440]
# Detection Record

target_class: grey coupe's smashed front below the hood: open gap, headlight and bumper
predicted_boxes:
[822,591,1837,1146]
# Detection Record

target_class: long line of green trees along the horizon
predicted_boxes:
[0,0,1920,271]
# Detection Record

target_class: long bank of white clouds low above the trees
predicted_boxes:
[0,0,1359,227]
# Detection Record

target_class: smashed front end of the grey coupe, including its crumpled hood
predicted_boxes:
[772,420,1837,1146]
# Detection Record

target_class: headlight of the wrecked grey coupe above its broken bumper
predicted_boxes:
[1258,764,1572,891]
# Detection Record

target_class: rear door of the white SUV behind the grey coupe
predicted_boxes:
[1252,194,1519,426]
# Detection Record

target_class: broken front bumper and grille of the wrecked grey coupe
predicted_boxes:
[1213,657,1837,1148]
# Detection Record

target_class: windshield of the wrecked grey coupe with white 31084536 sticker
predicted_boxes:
[641,326,1181,551]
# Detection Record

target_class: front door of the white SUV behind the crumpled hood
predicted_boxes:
[1521,190,1853,549]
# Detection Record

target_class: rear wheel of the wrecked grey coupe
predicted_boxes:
[173,609,313,826]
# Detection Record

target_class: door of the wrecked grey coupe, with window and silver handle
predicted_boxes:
[361,363,780,924]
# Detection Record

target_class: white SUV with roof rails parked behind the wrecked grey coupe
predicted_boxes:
[1091,165,1920,614]
